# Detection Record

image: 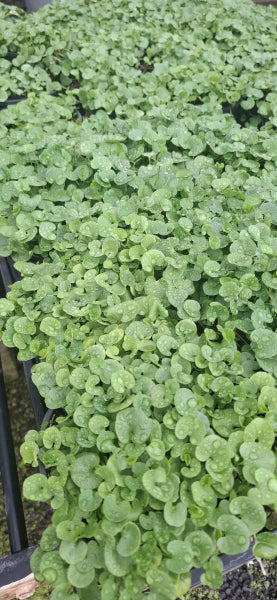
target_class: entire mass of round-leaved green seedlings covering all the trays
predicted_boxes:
[0,0,277,600]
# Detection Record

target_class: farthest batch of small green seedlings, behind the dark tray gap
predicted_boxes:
[0,0,277,125]
